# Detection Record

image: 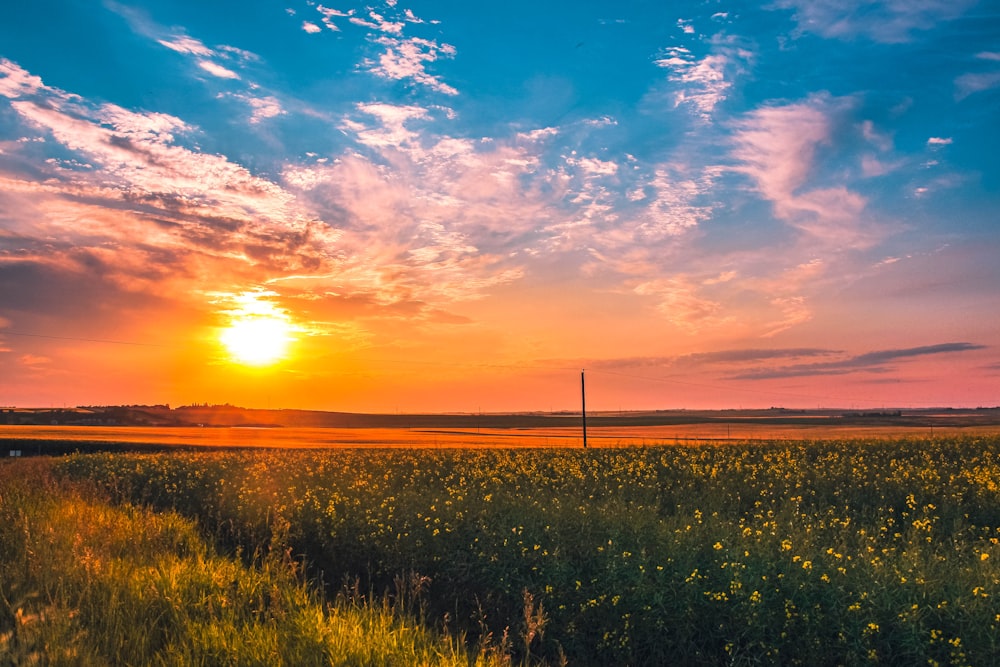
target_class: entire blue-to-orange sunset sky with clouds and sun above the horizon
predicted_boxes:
[0,0,1000,412]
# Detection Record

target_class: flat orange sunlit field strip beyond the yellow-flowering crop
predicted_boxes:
[0,419,1000,454]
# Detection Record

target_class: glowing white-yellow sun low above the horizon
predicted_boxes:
[219,293,294,366]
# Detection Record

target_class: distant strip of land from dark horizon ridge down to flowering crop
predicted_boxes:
[0,410,1000,454]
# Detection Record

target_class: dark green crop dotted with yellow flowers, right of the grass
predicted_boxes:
[61,437,1000,665]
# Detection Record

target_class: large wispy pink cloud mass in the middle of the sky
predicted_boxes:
[283,103,744,304]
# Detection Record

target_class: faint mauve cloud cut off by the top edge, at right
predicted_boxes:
[773,0,976,44]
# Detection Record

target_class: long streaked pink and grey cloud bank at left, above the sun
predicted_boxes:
[0,60,344,306]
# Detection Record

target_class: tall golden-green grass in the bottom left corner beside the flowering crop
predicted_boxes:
[0,460,504,666]
